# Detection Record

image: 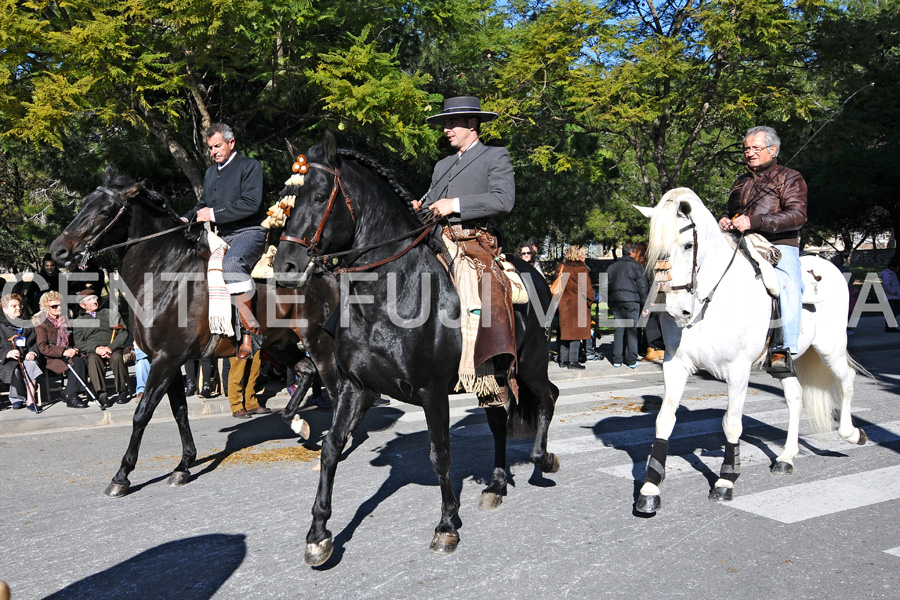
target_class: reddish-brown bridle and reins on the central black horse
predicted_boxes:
[279,154,437,275]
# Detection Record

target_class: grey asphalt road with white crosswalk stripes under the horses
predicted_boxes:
[0,344,900,600]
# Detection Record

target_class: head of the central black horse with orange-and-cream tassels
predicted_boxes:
[274,132,356,287]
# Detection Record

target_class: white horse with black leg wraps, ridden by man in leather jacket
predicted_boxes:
[635,188,866,514]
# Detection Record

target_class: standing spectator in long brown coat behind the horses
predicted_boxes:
[557,246,594,369]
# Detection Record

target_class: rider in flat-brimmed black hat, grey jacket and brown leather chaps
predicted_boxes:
[413,96,516,406]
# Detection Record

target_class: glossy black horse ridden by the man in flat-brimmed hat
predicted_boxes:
[275,133,559,565]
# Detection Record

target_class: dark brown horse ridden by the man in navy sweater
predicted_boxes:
[50,169,338,497]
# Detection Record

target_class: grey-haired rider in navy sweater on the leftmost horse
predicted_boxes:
[181,123,266,360]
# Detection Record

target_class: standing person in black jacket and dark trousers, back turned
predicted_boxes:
[606,243,650,369]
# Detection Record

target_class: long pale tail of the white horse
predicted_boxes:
[794,347,872,433]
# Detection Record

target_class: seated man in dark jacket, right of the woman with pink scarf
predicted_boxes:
[72,288,129,409]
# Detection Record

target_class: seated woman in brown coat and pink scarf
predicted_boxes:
[35,291,87,408]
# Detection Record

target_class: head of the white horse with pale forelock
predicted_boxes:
[637,188,721,327]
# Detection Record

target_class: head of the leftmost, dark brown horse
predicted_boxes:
[50,167,144,265]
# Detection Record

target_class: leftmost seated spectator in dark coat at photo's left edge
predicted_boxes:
[0,294,41,412]
